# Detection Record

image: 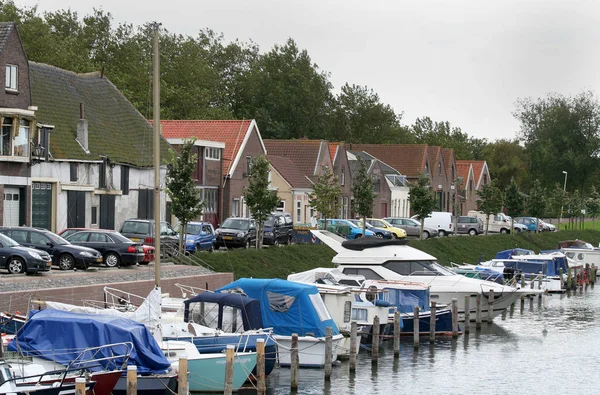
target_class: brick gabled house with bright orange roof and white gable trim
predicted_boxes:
[161,120,266,223]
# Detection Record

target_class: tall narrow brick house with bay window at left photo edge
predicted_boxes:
[0,22,37,226]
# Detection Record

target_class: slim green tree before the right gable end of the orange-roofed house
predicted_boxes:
[244,155,279,248]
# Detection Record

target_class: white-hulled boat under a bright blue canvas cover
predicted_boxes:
[215,278,344,368]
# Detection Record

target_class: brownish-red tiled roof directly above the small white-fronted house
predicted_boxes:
[348,144,427,178]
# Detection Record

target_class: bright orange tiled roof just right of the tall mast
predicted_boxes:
[150,120,253,175]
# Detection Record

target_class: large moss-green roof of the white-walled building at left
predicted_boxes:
[29,62,169,167]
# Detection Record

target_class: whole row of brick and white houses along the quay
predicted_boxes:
[0,23,489,231]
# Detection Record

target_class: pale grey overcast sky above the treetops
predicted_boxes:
[15,0,600,140]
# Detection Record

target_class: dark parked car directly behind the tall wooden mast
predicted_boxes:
[119,219,179,256]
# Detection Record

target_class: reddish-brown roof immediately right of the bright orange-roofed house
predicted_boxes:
[264,139,322,176]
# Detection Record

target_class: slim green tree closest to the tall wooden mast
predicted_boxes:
[165,139,203,256]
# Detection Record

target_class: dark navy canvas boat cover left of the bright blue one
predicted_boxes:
[183,292,264,330]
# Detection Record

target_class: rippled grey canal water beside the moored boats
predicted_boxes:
[241,287,600,395]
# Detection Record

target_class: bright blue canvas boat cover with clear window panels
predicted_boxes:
[215,278,339,337]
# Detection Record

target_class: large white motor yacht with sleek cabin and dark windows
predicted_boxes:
[311,229,535,321]
